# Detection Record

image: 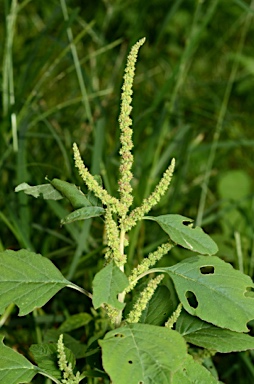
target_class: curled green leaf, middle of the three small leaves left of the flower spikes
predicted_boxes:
[50,179,91,209]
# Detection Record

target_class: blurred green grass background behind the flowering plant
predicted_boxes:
[0,0,254,384]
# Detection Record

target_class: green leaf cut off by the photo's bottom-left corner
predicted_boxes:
[0,338,38,384]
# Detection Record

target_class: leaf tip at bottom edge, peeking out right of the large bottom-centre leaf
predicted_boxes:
[171,355,219,384]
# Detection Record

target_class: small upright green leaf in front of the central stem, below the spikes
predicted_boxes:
[93,262,129,310]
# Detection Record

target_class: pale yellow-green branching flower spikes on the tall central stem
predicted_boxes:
[73,38,175,324]
